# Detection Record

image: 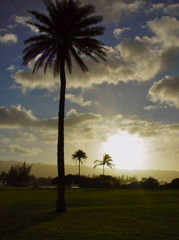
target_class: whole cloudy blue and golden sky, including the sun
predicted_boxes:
[0,0,179,173]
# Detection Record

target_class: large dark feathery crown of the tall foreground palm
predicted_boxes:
[23,0,106,75]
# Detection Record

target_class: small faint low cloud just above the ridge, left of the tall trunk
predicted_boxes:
[10,144,42,156]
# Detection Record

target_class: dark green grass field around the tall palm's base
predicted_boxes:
[0,187,179,240]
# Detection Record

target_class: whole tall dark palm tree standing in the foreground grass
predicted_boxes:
[23,0,106,212]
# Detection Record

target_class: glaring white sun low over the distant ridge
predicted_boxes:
[104,132,145,170]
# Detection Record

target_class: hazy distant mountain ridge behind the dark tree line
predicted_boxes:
[0,160,179,182]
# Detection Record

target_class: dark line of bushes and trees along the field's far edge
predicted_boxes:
[0,162,179,189]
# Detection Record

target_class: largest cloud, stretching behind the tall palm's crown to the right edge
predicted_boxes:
[12,13,179,92]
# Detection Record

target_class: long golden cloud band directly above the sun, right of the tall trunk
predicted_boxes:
[65,110,179,142]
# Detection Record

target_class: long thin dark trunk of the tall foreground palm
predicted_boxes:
[56,60,66,213]
